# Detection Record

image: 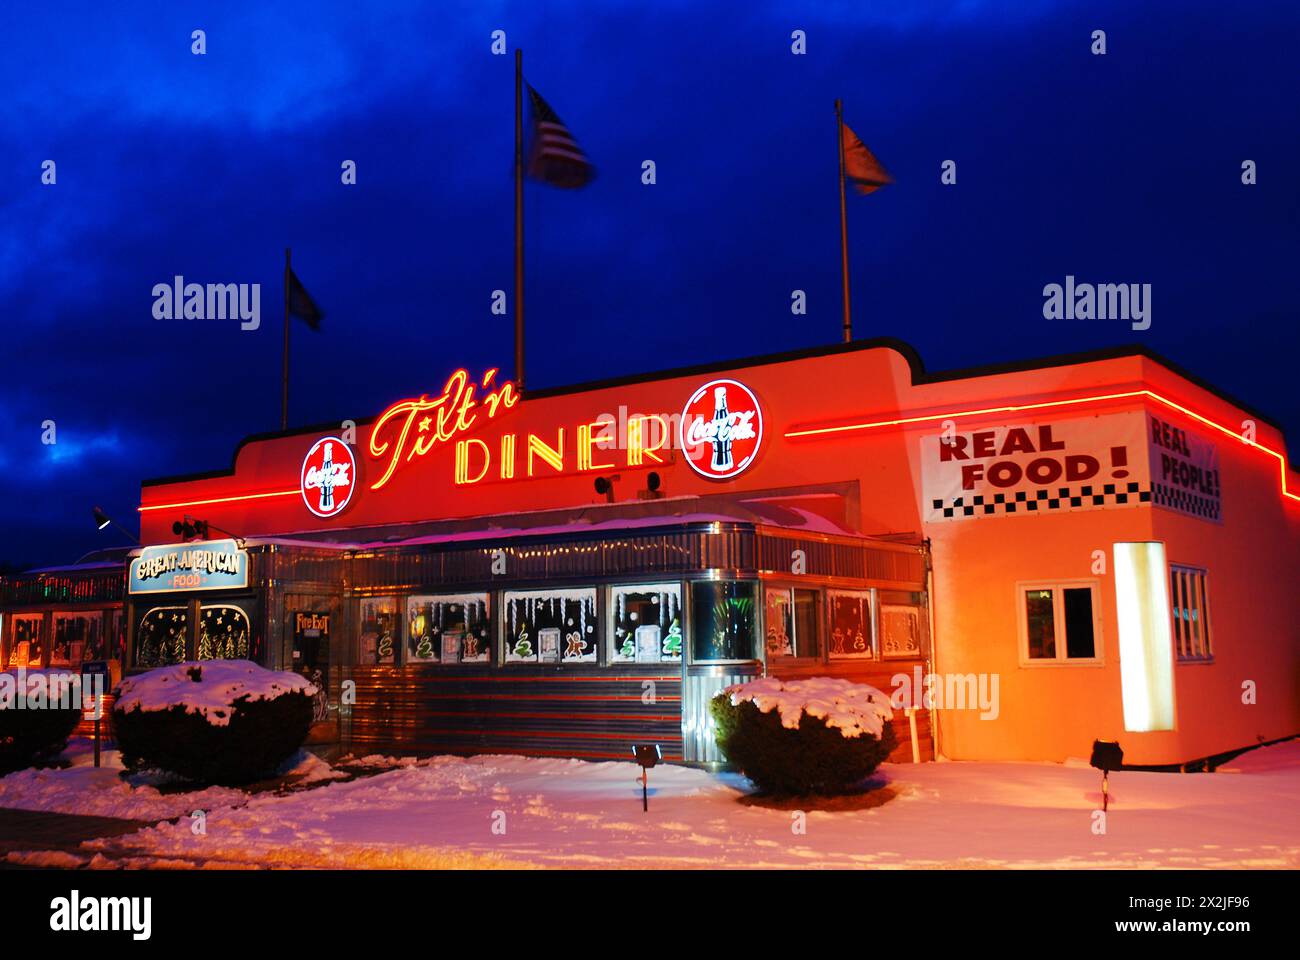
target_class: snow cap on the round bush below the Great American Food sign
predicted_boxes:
[113,660,316,727]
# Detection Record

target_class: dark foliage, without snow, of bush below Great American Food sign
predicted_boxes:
[113,661,312,786]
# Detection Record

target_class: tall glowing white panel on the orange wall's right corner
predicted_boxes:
[1114,542,1174,732]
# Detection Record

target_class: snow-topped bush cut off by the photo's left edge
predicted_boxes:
[0,670,82,775]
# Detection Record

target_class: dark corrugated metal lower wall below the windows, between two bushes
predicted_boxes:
[343,667,683,760]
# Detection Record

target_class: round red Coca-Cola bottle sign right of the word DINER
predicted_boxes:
[677,380,763,480]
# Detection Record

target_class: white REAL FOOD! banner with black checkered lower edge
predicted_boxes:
[920,412,1152,523]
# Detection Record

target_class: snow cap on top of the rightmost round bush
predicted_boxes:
[723,676,893,740]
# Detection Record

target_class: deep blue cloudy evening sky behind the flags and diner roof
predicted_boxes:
[0,0,1300,563]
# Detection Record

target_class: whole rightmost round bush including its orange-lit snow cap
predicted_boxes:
[710,676,897,796]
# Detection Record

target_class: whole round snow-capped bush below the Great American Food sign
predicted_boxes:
[113,660,316,784]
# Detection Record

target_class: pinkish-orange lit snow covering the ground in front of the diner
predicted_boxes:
[61,741,1300,868]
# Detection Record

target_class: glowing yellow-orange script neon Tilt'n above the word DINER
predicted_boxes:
[371,367,519,490]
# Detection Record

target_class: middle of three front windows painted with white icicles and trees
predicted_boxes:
[502,587,598,663]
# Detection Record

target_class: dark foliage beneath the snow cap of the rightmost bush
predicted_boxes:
[710,692,898,796]
